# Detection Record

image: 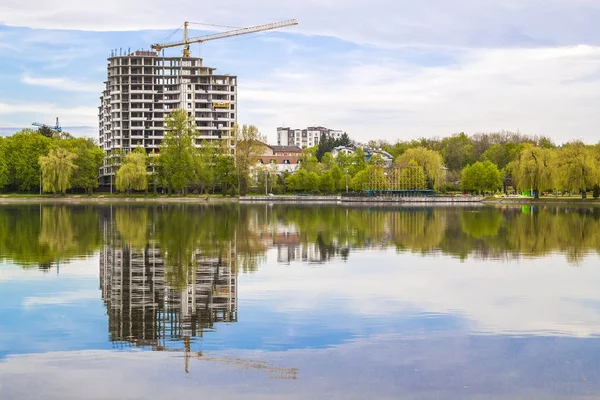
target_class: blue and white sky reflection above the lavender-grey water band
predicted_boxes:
[0,250,600,356]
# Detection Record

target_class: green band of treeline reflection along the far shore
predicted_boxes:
[0,204,600,272]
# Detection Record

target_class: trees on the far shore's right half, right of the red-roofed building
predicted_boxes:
[285,133,600,198]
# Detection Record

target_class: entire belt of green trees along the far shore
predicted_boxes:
[0,110,600,198]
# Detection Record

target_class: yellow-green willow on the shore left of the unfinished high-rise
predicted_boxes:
[39,147,77,194]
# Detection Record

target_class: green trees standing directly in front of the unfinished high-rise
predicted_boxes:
[115,110,264,194]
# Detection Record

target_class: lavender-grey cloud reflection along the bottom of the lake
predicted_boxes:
[0,335,600,400]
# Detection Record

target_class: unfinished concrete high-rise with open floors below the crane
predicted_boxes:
[98,51,237,184]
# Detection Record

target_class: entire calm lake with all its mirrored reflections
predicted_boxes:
[0,204,600,400]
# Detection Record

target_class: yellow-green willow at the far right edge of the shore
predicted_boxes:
[556,142,600,199]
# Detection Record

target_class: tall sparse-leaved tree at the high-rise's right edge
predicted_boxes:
[231,124,266,196]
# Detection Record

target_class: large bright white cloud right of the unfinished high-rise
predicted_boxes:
[239,46,600,142]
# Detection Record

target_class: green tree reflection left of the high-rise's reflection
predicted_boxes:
[0,205,102,268]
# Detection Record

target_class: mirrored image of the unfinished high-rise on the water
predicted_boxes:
[100,242,237,349]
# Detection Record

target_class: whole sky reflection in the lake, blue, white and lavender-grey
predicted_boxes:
[0,250,600,400]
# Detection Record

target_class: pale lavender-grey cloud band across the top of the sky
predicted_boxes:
[0,0,600,46]
